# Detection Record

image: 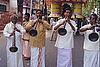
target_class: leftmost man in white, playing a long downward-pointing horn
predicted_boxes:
[3,14,26,67]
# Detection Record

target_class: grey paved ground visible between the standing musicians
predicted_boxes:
[0,31,83,67]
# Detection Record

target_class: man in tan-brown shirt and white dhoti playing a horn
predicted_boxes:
[25,10,52,67]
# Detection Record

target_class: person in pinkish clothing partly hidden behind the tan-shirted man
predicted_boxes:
[23,13,32,60]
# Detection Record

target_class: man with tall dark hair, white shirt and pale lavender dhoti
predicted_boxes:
[54,4,77,67]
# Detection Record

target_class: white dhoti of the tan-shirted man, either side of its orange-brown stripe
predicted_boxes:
[30,47,45,67]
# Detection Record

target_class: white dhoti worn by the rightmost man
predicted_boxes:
[84,50,99,67]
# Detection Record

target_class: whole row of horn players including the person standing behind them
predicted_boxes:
[3,6,100,67]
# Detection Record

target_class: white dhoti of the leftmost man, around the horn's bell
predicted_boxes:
[6,38,23,67]
